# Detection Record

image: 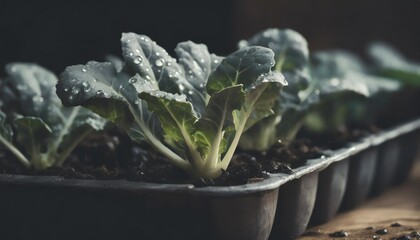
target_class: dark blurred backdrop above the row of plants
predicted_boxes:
[0,0,420,76]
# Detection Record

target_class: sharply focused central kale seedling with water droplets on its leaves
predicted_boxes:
[57,33,287,179]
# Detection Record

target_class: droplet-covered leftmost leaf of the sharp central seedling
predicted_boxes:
[57,61,148,135]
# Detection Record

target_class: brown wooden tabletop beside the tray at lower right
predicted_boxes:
[299,159,420,240]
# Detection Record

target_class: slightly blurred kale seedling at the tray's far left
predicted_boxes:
[0,63,105,170]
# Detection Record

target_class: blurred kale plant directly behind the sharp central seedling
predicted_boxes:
[239,29,311,151]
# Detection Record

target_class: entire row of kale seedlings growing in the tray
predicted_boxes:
[0,29,420,179]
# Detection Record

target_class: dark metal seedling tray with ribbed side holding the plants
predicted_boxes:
[0,119,420,240]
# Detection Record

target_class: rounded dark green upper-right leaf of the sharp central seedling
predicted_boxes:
[207,46,274,95]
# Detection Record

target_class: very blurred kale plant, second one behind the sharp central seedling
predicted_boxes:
[306,50,400,132]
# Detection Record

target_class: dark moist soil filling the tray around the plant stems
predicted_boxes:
[0,124,374,186]
